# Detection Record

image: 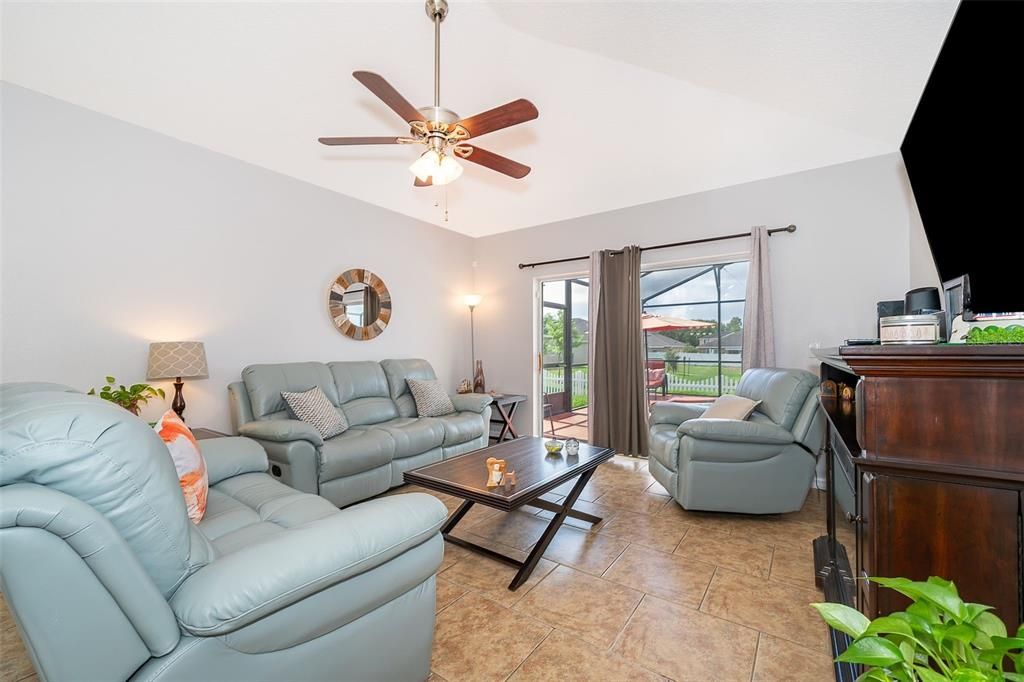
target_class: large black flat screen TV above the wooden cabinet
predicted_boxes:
[900,0,1024,313]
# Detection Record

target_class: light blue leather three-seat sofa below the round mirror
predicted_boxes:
[227,359,492,507]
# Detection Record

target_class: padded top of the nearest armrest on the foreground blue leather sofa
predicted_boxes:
[171,493,447,636]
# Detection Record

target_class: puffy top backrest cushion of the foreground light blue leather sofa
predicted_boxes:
[0,385,197,597]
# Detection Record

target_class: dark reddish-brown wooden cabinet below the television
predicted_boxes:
[841,345,1024,629]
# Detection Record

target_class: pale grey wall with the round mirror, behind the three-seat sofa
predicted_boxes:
[0,84,472,428]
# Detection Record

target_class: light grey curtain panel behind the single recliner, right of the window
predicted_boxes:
[743,225,775,370]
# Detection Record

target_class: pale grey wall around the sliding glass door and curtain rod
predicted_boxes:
[474,154,934,432]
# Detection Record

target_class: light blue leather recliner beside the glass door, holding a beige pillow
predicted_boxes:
[648,369,824,514]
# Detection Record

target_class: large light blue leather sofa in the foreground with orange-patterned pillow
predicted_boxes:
[0,384,445,682]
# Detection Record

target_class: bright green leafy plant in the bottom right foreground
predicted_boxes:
[811,577,1024,682]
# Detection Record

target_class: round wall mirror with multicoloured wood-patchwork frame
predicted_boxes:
[327,268,391,341]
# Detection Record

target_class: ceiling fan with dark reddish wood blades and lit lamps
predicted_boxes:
[319,0,538,187]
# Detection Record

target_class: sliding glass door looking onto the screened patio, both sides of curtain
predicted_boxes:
[537,261,748,440]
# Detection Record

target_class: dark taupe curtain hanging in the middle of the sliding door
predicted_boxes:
[589,246,647,457]
